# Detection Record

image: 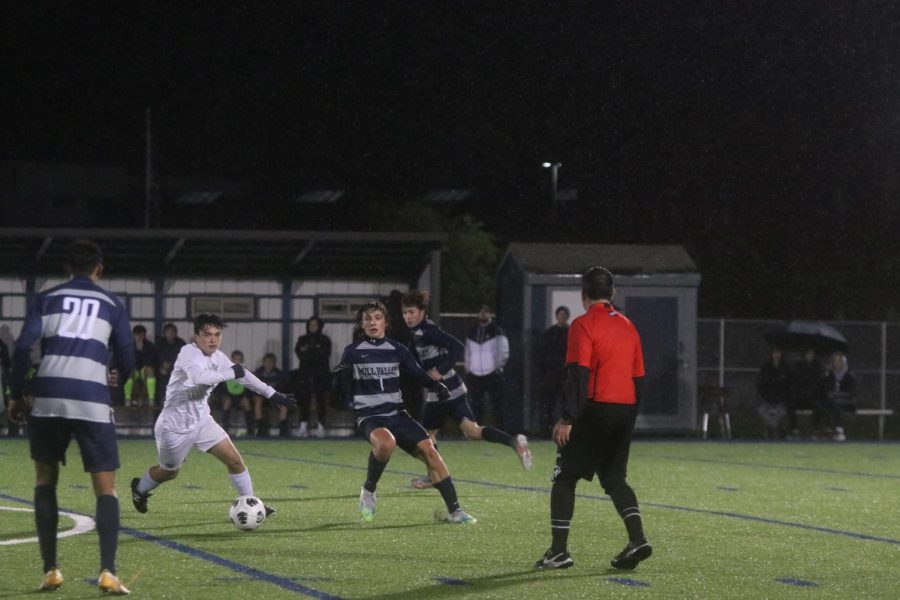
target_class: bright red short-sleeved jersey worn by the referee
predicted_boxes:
[566,302,644,404]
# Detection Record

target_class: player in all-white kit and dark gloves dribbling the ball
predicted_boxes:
[131,313,297,516]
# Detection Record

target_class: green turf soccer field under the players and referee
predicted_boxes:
[0,439,900,600]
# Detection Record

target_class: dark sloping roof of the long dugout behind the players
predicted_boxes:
[0,227,447,278]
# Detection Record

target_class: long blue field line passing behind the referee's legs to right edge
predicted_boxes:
[243,452,900,546]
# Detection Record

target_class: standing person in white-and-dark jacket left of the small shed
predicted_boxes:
[465,304,509,429]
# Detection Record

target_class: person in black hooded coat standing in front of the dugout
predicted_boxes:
[294,316,331,438]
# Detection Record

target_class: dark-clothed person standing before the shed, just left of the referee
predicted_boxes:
[538,306,571,437]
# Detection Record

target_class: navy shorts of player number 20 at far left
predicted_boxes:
[28,416,119,473]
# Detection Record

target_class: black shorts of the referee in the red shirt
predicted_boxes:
[554,402,637,483]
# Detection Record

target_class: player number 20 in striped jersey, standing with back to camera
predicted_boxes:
[9,240,134,595]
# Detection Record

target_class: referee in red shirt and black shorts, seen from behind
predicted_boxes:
[535,267,653,569]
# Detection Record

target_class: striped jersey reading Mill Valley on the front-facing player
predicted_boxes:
[341,338,438,423]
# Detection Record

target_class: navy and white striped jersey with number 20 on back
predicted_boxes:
[14,277,134,423]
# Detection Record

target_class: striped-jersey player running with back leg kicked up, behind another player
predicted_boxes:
[402,290,531,489]
